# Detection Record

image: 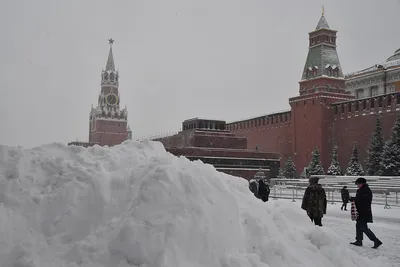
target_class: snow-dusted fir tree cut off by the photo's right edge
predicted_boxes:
[380,112,400,176]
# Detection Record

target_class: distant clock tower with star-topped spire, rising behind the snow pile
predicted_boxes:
[89,39,131,146]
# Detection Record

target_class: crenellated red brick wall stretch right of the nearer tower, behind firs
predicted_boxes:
[333,95,400,170]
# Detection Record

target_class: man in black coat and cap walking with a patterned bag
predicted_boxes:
[350,178,382,249]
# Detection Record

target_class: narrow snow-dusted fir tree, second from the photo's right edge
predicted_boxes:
[365,116,385,176]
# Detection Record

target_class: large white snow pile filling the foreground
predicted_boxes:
[0,141,388,267]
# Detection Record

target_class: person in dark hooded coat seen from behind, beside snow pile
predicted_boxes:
[301,177,327,226]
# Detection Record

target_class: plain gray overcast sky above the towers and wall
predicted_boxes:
[0,0,400,147]
